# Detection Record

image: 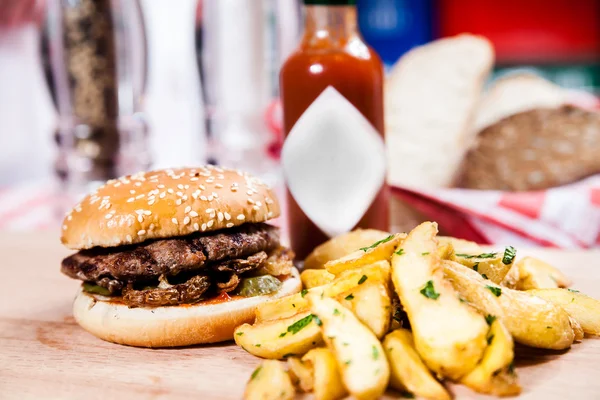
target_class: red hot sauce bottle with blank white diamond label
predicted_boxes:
[280,0,389,259]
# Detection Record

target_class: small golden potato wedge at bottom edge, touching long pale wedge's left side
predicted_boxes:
[302,348,348,400]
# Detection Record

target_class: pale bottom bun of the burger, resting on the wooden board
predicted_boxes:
[73,268,302,347]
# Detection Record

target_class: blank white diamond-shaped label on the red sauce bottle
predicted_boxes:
[281,86,386,237]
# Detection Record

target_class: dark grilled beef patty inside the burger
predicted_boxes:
[61,223,279,297]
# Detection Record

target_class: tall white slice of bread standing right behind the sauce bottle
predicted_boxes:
[385,34,494,188]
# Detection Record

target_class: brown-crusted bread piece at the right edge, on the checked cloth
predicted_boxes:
[457,106,600,191]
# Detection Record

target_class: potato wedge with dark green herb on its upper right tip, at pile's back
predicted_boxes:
[451,246,516,284]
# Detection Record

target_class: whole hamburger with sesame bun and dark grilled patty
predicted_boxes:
[61,166,301,347]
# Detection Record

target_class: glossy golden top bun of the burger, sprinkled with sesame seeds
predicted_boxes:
[61,166,280,250]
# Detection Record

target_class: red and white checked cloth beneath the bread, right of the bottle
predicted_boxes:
[393,175,600,249]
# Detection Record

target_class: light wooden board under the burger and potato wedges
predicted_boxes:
[0,233,600,400]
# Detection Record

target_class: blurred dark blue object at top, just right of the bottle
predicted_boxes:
[357,0,435,69]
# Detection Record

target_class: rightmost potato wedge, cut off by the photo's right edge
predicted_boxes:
[527,289,600,336]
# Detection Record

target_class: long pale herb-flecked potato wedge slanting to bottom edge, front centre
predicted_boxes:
[307,294,390,399]
